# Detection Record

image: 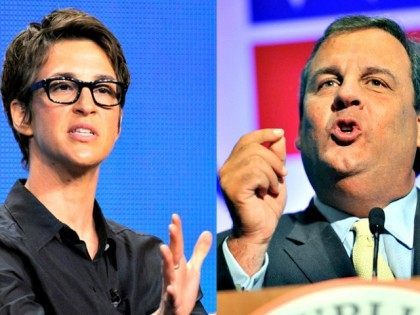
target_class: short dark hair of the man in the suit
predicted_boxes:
[299,15,420,174]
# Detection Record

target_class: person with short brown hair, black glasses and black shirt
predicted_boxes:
[0,9,211,314]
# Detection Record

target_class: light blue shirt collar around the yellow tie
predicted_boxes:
[314,185,417,249]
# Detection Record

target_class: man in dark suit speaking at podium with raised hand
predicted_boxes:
[218,16,420,290]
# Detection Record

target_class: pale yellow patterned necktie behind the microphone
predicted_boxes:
[352,218,394,280]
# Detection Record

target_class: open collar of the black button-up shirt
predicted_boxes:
[5,179,116,268]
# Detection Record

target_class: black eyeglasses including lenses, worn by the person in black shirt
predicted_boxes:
[30,77,127,107]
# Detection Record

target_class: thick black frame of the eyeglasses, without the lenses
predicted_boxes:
[29,77,128,108]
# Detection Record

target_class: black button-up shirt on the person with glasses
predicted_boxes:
[0,181,205,315]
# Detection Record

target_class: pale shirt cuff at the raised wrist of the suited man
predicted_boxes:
[222,237,268,291]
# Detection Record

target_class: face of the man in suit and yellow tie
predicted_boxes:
[297,28,418,187]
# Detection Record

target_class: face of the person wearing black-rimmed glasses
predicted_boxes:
[23,40,121,173]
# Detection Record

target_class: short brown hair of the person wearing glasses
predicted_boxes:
[1,9,130,167]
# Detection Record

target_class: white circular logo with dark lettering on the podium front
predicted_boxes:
[253,279,420,315]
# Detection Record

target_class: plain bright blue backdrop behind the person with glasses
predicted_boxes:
[0,0,216,312]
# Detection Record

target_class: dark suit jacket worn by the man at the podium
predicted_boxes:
[217,198,420,290]
